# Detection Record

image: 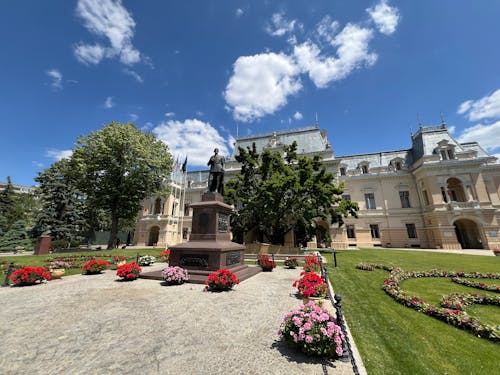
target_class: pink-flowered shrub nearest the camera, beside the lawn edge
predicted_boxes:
[278,301,345,357]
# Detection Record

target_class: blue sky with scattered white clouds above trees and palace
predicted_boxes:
[0,0,500,185]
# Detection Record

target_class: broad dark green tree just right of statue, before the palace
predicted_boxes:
[225,142,357,244]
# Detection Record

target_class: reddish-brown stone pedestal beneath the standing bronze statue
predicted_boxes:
[141,192,260,284]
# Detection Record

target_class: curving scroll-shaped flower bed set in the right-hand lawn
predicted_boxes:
[356,263,500,342]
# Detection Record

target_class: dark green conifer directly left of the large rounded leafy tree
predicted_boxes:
[32,159,86,240]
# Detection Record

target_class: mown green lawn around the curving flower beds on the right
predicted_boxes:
[328,249,500,375]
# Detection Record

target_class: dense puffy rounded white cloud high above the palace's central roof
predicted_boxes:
[224,53,302,122]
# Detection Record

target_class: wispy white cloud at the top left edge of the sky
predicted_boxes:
[74,0,141,65]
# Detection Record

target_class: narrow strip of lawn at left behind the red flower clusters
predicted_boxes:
[0,248,164,283]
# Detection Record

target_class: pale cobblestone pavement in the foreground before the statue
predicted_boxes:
[0,264,353,375]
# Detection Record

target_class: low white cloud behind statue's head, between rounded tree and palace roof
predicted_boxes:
[152,119,229,167]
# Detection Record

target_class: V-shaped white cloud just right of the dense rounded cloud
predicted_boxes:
[293,23,377,88]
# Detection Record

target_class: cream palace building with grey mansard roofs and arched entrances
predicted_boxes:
[134,124,500,249]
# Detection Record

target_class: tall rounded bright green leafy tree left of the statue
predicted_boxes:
[71,122,172,249]
